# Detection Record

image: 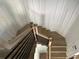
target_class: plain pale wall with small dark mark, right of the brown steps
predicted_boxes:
[66,17,79,57]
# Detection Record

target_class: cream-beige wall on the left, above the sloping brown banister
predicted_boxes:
[0,0,30,45]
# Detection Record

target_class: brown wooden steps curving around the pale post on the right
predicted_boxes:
[38,26,66,59]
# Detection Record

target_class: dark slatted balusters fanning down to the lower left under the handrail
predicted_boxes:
[5,31,35,59]
